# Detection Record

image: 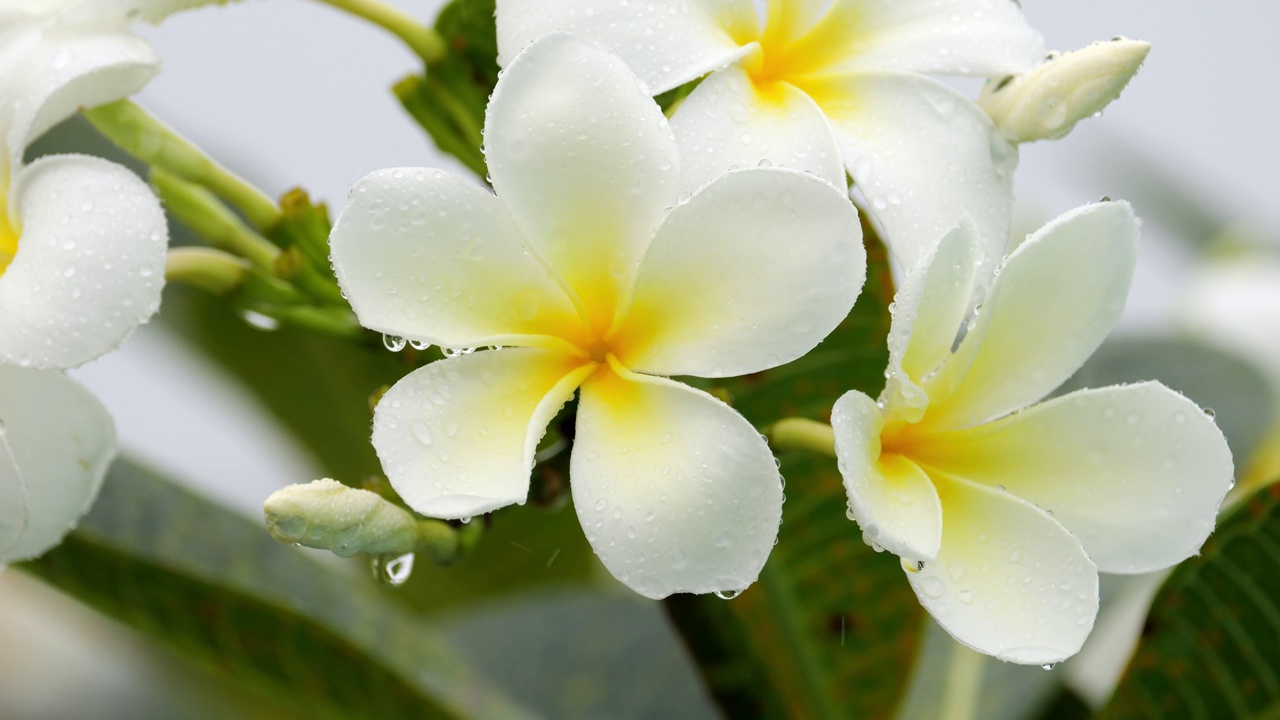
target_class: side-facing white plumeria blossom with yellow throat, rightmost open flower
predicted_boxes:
[832,202,1233,664]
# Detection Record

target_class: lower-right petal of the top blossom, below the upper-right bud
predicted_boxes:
[803,72,1018,286]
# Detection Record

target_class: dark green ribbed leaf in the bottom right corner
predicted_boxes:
[1101,484,1280,720]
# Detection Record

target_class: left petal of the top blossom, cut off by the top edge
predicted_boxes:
[498,0,759,95]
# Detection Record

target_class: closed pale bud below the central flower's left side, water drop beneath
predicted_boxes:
[262,479,419,557]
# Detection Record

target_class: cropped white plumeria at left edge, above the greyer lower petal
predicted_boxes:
[0,0,196,368]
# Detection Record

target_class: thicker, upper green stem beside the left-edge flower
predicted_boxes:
[84,100,280,231]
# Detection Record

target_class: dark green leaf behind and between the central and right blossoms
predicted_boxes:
[666,228,923,717]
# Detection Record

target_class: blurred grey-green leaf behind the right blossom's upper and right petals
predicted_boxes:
[1055,337,1275,464]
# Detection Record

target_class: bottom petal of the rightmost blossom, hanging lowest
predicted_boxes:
[908,478,1098,665]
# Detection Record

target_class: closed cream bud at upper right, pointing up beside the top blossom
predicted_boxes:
[978,37,1151,142]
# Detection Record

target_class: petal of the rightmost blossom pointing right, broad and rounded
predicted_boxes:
[918,383,1233,573]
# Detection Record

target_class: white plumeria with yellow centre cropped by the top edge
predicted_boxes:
[498,0,1043,285]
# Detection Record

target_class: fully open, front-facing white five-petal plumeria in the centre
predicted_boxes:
[330,35,865,598]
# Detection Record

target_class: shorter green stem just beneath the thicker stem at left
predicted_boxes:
[151,168,280,273]
